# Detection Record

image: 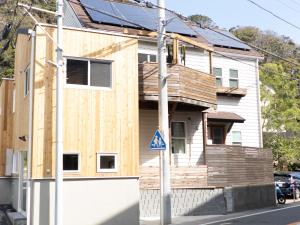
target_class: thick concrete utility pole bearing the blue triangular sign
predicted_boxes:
[157,0,171,225]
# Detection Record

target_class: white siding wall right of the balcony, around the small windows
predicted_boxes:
[213,56,261,147]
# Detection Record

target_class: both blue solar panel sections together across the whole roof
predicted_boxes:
[80,0,250,50]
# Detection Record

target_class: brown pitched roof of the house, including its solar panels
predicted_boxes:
[68,0,261,57]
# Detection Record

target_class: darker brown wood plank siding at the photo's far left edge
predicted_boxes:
[0,80,14,176]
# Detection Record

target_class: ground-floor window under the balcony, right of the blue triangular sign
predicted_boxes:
[171,122,186,154]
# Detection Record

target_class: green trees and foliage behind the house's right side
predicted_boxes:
[231,27,300,170]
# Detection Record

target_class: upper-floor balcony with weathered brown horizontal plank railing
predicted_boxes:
[139,63,216,108]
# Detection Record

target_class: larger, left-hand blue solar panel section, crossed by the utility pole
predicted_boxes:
[80,0,196,36]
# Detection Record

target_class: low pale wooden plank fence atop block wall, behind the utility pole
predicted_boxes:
[140,165,207,189]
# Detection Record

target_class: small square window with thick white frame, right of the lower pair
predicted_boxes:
[97,153,117,172]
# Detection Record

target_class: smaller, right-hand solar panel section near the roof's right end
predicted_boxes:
[195,27,251,50]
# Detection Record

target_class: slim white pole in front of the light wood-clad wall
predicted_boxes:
[55,0,63,225]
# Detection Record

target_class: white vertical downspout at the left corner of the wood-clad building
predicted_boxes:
[26,30,36,225]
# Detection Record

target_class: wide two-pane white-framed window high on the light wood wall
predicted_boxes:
[64,56,114,91]
